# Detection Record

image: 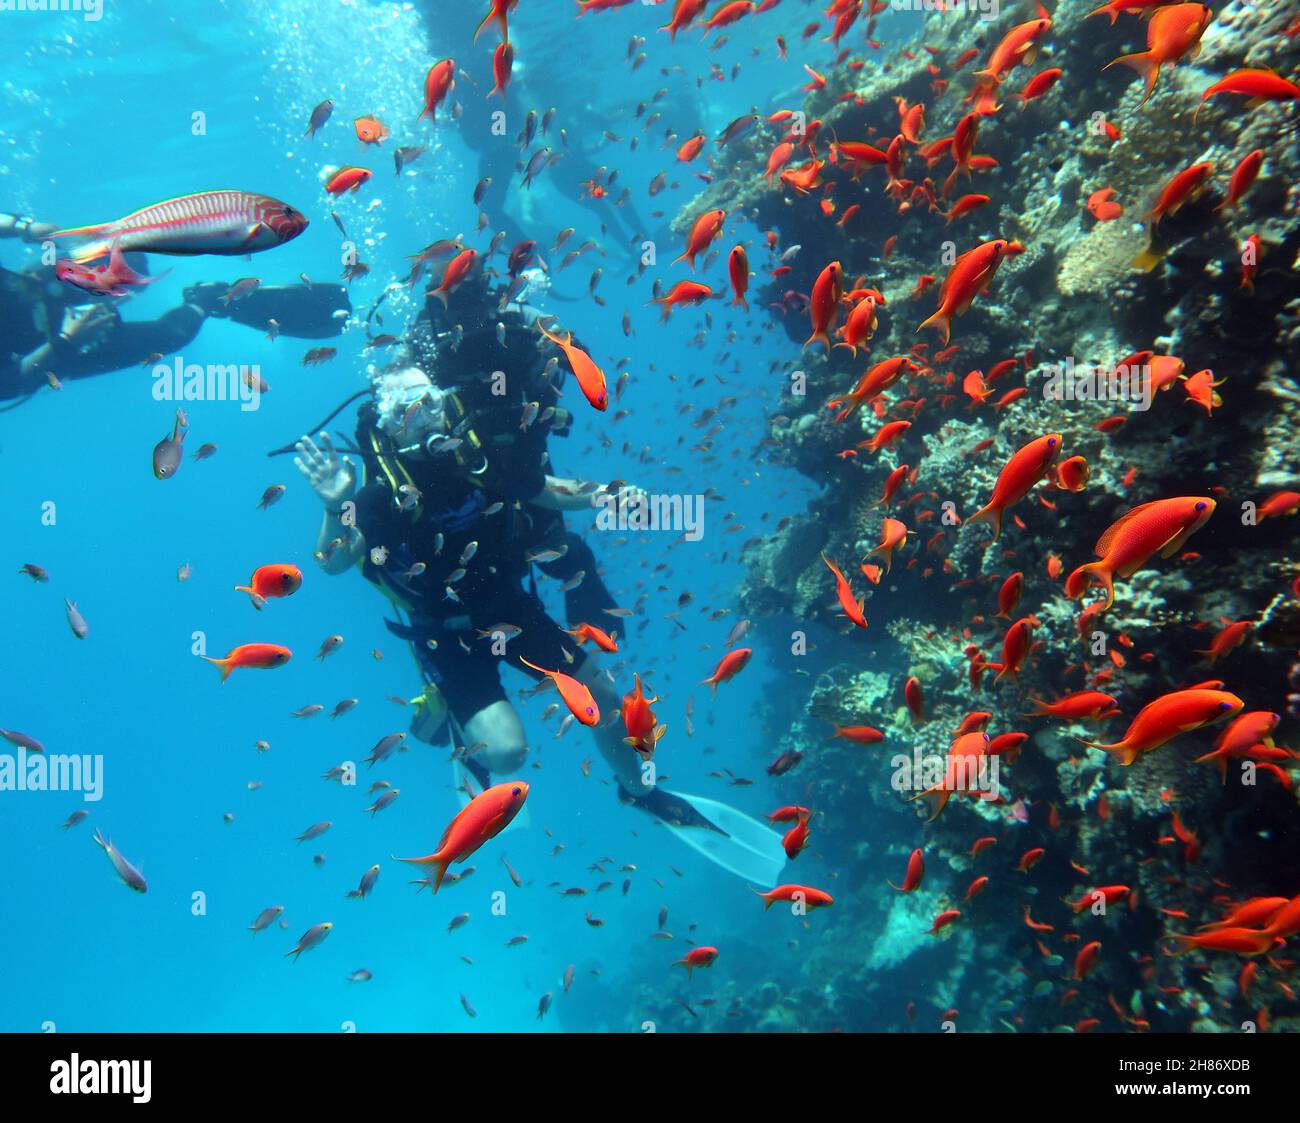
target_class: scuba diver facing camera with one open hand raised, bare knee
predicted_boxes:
[292,270,784,880]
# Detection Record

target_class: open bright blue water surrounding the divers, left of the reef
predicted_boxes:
[0,0,828,1032]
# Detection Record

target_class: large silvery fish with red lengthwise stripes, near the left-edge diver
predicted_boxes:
[52,191,307,265]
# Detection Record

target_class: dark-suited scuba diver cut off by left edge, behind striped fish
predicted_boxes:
[0,207,352,409]
